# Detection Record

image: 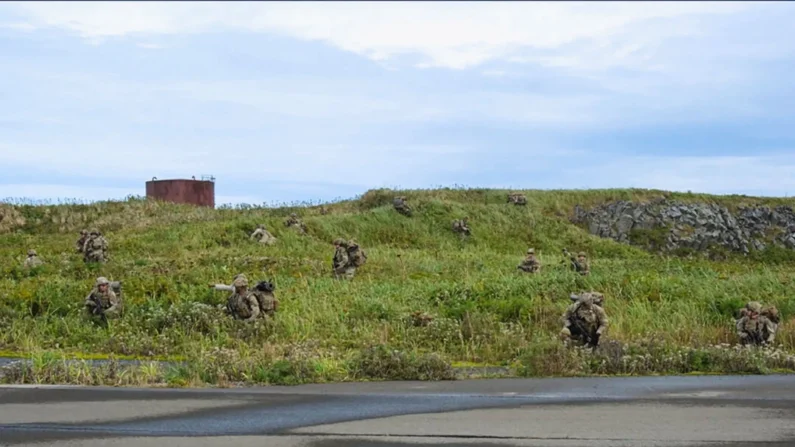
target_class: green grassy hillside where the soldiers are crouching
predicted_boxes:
[0,189,795,384]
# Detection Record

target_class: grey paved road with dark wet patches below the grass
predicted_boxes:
[0,376,795,447]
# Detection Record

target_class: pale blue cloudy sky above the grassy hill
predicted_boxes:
[0,2,795,205]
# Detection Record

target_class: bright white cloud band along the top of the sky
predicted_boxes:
[1,2,756,69]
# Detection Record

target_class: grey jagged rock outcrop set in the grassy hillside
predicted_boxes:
[573,199,795,253]
